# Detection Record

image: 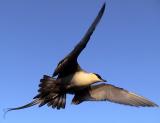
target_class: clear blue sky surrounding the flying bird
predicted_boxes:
[0,0,160,123]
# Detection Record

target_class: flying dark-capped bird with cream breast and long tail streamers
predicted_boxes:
[6,3,158,112]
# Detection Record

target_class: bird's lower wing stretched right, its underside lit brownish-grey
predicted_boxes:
[72,84,158,107]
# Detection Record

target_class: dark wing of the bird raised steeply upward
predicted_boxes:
[53,3,105,77]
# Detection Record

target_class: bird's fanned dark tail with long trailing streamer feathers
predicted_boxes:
[4,75,66,116]
